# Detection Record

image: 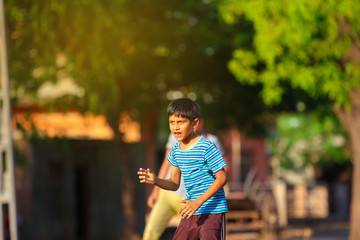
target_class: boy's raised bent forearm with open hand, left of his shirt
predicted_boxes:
[137,166,181,191]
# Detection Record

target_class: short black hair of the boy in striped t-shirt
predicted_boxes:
[167,98,200,122]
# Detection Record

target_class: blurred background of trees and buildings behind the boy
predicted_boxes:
[1,0,360,240]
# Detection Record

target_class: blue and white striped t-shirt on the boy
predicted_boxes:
[168,136,228,215]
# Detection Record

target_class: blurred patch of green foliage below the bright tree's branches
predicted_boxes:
[269,113,351,183]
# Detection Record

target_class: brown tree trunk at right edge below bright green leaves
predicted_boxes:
[335,90,360,240]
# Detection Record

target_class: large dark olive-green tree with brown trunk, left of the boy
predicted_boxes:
[5,0,263,239]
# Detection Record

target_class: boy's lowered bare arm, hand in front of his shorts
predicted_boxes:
[179,169,227,218]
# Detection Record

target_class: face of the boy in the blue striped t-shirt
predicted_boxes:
[169,115,199,142]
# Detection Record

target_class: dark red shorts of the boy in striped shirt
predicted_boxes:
[173,213,226,240]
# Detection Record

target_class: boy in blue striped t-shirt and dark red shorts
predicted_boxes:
[138,98,228,240]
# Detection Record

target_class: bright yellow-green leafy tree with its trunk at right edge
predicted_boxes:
[219,0,360,240]
